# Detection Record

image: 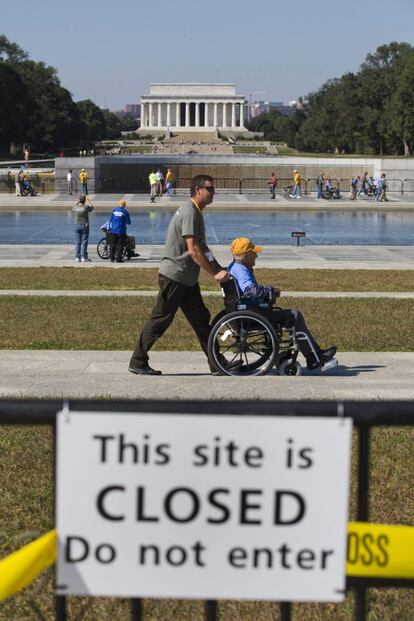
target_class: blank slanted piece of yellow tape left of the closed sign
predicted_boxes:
[0,530,57,601]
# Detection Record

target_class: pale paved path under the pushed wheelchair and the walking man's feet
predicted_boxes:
[0,350,414,400]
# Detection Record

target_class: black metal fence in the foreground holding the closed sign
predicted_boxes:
[0,400,414,621]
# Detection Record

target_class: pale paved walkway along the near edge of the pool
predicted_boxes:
[0,244,414,270]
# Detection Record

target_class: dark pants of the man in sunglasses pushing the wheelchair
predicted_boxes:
[129,274,210,368]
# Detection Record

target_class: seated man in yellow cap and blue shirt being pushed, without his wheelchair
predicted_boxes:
[227,237,336,370]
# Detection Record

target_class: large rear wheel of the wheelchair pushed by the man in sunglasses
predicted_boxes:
[208,311,279,376]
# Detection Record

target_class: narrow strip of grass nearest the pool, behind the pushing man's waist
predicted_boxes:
[0,267,414,291]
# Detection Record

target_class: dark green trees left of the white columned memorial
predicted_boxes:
[0,34,137,154]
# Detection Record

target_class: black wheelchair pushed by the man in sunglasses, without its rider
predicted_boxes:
[208,279,337,377]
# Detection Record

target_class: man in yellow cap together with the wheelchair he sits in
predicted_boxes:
[208,237,337,376]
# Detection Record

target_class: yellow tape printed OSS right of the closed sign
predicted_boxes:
[346,522,414,579]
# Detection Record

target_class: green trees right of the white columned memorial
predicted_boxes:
[250,42,414,155]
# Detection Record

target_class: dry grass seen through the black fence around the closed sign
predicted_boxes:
[0,426,414,621]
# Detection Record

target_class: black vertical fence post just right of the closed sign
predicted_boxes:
[355,425,370,621]
